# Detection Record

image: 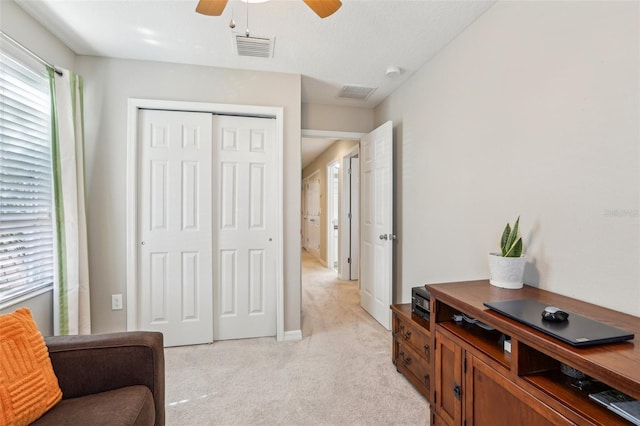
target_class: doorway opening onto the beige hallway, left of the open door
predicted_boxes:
[300,135,360,330]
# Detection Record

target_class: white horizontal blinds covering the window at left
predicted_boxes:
[0,53,55,308]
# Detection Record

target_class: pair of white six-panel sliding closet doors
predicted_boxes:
[137,110,278,346]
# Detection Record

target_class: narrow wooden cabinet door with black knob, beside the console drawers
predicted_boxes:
[434,330,462,426]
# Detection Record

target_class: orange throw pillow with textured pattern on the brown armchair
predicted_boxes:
[0,308,62,426]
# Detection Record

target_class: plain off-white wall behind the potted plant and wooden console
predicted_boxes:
[375,1,640,315]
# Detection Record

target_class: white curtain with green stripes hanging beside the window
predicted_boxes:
[49,69,91,335]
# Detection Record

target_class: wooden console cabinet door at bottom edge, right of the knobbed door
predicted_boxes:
[464,353,573,426]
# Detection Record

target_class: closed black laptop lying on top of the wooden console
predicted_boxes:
[484,299,634,346]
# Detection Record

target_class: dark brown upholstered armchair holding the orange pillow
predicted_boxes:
[33,331,165,426]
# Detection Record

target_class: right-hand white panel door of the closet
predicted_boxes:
[213,116,279,340]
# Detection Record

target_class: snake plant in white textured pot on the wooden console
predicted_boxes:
[489,216,525,289]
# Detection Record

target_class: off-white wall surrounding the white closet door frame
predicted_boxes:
[77,56,301,333]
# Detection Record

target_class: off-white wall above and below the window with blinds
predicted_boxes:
[0,0,76,336]
